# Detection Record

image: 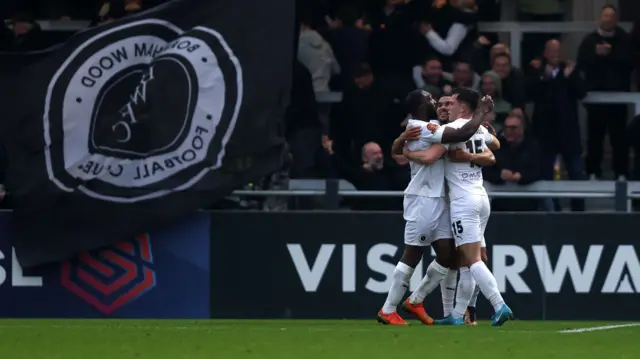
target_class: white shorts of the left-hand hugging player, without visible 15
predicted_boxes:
[404,195,453,247]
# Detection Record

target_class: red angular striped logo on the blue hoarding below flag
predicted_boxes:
[61,234,156,315]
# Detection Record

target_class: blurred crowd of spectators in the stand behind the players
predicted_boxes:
[0,0,640,211]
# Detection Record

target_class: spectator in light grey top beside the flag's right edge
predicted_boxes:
[298,20,340,92]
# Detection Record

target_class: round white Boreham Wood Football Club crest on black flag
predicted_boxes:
[44,19,243,203]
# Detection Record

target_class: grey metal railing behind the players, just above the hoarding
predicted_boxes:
[233,179,640,212]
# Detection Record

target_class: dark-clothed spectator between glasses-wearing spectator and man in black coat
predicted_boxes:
[491,52,526,116]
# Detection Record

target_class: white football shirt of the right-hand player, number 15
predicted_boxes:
[443,119,493,200]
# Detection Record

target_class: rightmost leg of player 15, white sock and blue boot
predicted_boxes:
[461,196,513,326]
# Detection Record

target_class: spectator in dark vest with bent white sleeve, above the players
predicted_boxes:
[420,0,479,71]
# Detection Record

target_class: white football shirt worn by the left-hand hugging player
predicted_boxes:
[404,119,448,198]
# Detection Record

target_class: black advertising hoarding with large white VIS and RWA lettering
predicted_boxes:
[211,212,640,320]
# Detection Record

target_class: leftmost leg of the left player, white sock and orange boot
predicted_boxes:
[378,196,426,325]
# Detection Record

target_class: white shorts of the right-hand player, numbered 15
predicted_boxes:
[451,195,491,247]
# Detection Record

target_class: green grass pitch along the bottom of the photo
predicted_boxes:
[0,319,640,359]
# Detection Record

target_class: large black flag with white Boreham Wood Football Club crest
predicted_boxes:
[1,0,294,267]
